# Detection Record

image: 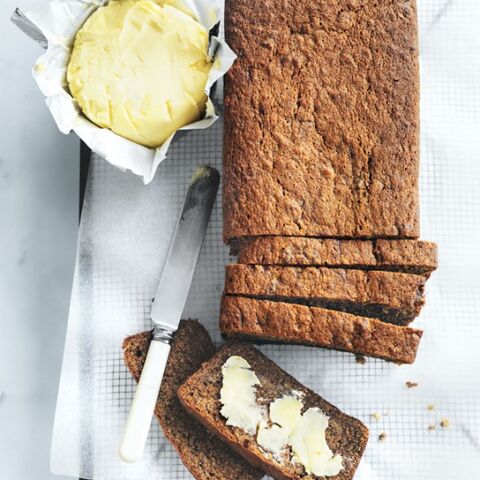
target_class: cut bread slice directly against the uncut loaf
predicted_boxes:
[232,236,437,274]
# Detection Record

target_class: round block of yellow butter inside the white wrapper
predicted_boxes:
[67,0,211,147]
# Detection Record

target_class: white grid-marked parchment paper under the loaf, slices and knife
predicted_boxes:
[51,0,480,480]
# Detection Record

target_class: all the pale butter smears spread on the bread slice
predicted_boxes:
[220,356,343,477]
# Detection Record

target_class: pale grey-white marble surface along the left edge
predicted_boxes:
[0,0,79,480]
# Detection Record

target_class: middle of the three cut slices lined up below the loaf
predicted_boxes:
[225,264,426,325]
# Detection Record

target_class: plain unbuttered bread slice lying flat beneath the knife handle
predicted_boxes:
[123,320,264,480]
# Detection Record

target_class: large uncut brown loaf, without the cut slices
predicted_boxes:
[223,0,419,242]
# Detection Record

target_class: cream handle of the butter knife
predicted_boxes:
[119,340,170,463]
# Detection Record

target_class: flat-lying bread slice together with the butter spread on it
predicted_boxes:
[178,343,368,480]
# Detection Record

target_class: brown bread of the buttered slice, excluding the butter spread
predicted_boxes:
[178,343,368,480]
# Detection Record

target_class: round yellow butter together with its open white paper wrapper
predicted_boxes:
[25,0,235,183]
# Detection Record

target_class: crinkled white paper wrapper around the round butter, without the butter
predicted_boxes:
[25,0,235,183]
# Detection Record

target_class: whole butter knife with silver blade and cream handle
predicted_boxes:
[119,166,220,462]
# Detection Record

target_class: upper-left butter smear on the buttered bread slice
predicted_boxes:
[220,356,265,435]
